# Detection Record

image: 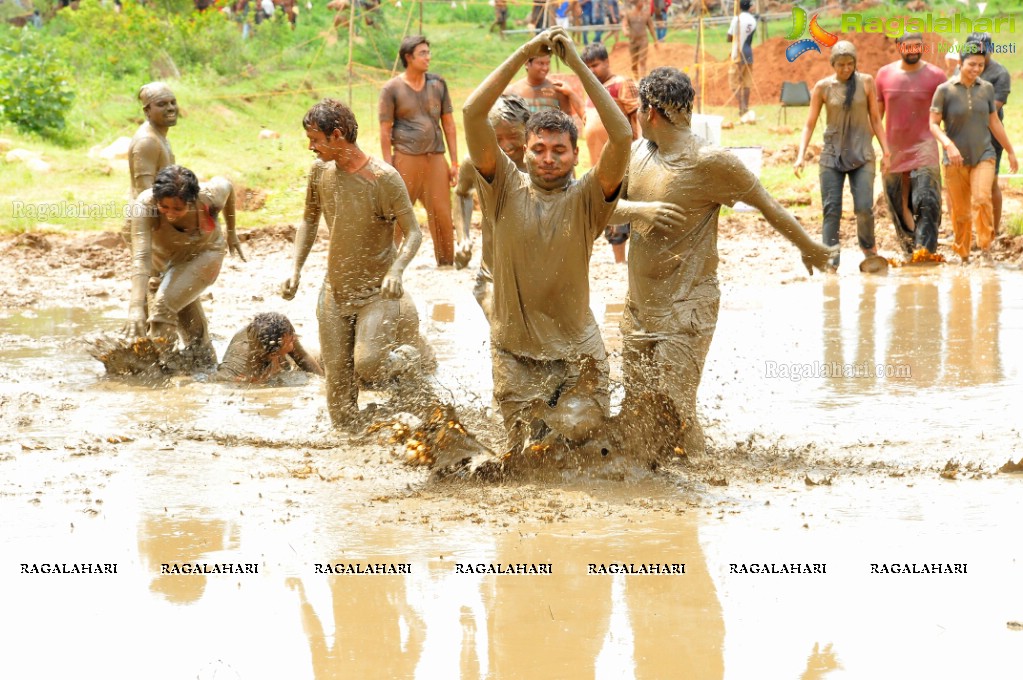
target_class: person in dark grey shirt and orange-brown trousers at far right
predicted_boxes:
[931,42,1019,263]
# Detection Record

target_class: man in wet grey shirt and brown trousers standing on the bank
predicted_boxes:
[380,36,458,267]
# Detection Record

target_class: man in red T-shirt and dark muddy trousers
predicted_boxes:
[876,33,946,255]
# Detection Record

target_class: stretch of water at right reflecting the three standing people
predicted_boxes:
[700,267,1023,464]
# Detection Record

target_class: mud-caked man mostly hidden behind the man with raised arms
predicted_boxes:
[454,94,529,314]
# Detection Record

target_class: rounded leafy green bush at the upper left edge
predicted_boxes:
[0,28,75,135]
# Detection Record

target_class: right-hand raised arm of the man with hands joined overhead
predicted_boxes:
[550,29,632,198]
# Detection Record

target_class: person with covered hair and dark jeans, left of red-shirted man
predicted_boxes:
[793,40,891,267]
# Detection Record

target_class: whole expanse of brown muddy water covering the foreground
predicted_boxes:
[0,267,1023,680]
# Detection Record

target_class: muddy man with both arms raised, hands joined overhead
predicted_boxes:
[462,29,632,451]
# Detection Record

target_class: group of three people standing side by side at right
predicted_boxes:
[794,33,1018,266]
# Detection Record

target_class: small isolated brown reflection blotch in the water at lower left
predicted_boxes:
[138,515,238,604]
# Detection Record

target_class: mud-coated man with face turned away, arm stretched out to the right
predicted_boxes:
[622,67,837,456]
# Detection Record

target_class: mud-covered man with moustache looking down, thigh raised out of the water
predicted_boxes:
[281,99,424,428]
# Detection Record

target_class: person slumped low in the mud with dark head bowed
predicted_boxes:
[214,312,323,383]
